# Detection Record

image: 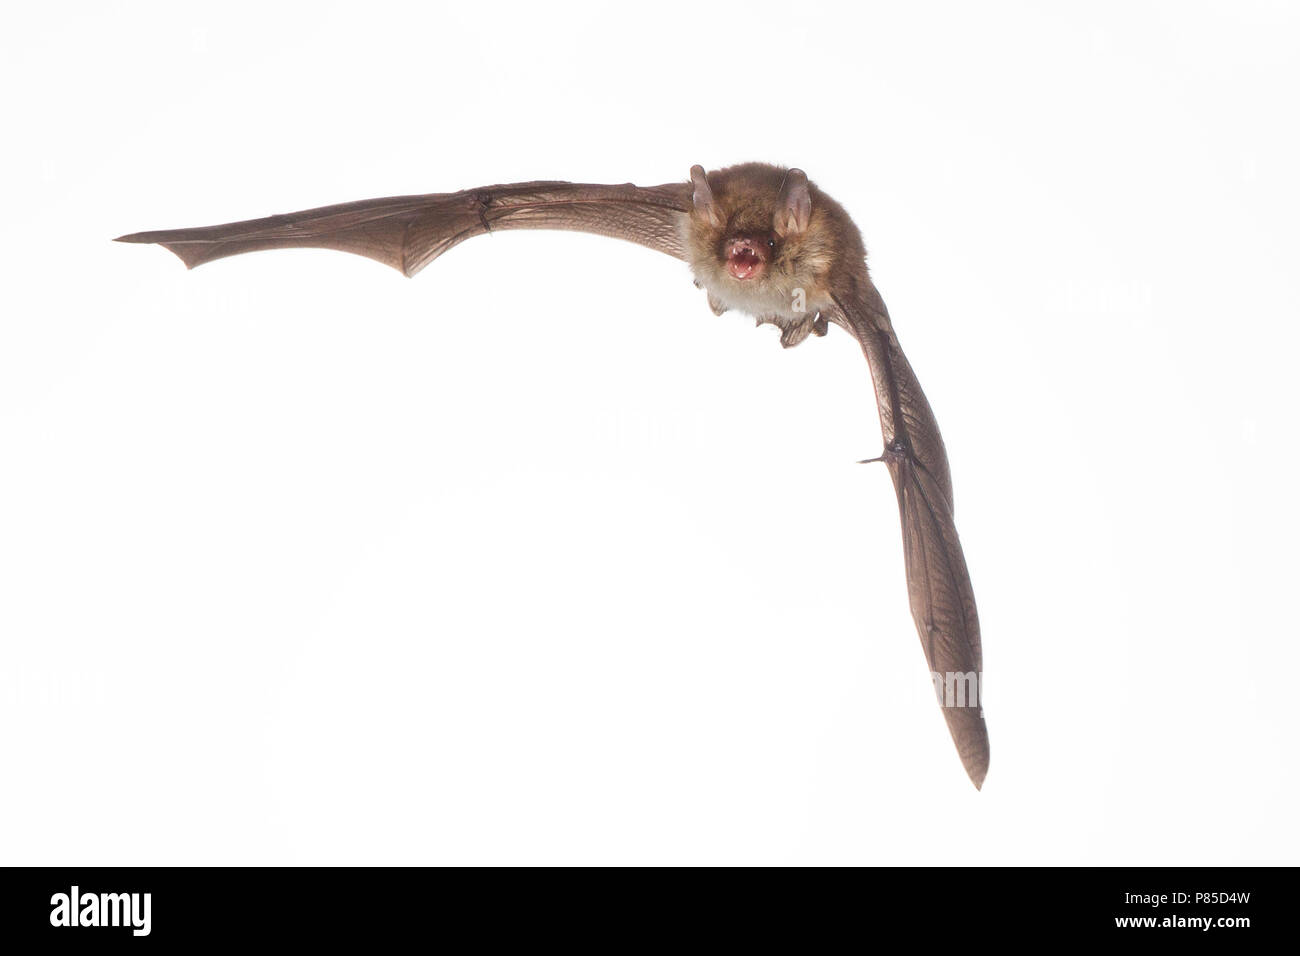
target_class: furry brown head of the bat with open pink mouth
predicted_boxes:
[685,163,837,325]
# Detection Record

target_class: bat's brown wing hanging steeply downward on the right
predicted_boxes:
[827,277,988,788]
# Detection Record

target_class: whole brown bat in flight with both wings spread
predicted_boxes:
[118,163,988,788]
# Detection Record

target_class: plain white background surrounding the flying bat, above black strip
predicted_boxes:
[0,3,1300,865]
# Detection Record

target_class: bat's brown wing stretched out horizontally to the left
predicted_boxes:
[117,182,692,276]
